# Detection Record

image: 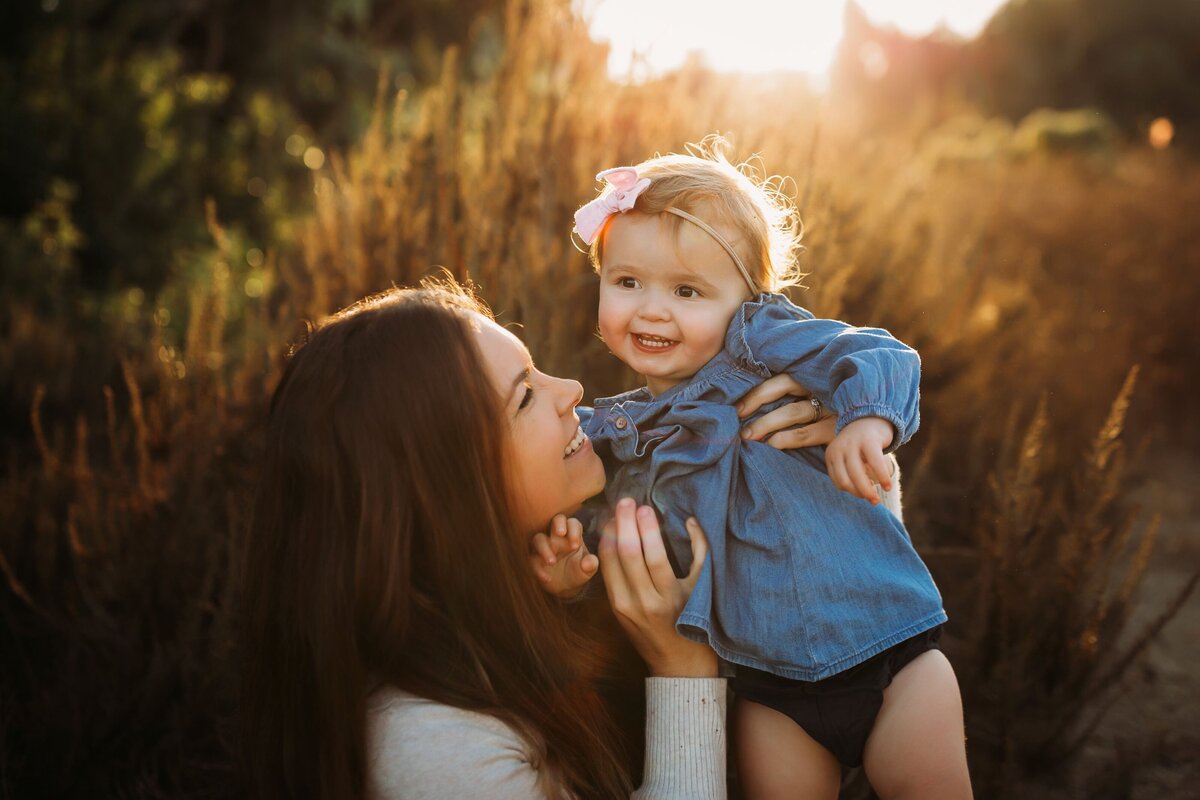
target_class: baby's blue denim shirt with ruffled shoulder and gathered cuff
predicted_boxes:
[578,294,946,681]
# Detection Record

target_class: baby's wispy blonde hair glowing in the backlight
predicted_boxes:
[588,133,804,291]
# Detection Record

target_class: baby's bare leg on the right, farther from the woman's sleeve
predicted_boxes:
[863,650,972,800]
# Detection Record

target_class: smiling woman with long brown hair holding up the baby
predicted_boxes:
[241,278,844,798]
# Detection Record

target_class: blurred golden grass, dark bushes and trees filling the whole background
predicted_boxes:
[0,0,1200,798]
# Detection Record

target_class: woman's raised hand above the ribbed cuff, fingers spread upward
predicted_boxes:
[600,498,716,678]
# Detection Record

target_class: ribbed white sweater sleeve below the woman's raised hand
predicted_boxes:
[634,678,726,800]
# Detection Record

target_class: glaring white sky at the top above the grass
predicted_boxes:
[576,0,1004,76]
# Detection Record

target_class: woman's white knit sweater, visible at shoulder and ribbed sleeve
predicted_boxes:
[367,678,726,800]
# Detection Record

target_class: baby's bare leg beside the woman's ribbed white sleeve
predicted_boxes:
[733,698,841,800]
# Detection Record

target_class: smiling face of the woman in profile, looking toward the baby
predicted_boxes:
[475,314,605,533]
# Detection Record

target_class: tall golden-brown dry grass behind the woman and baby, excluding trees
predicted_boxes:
[0,0,1200,798]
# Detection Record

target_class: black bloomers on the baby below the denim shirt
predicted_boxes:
[732,625,942,766]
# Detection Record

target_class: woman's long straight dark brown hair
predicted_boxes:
[241,283,629,798]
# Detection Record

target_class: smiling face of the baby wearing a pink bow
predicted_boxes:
[600,211,750,395]
